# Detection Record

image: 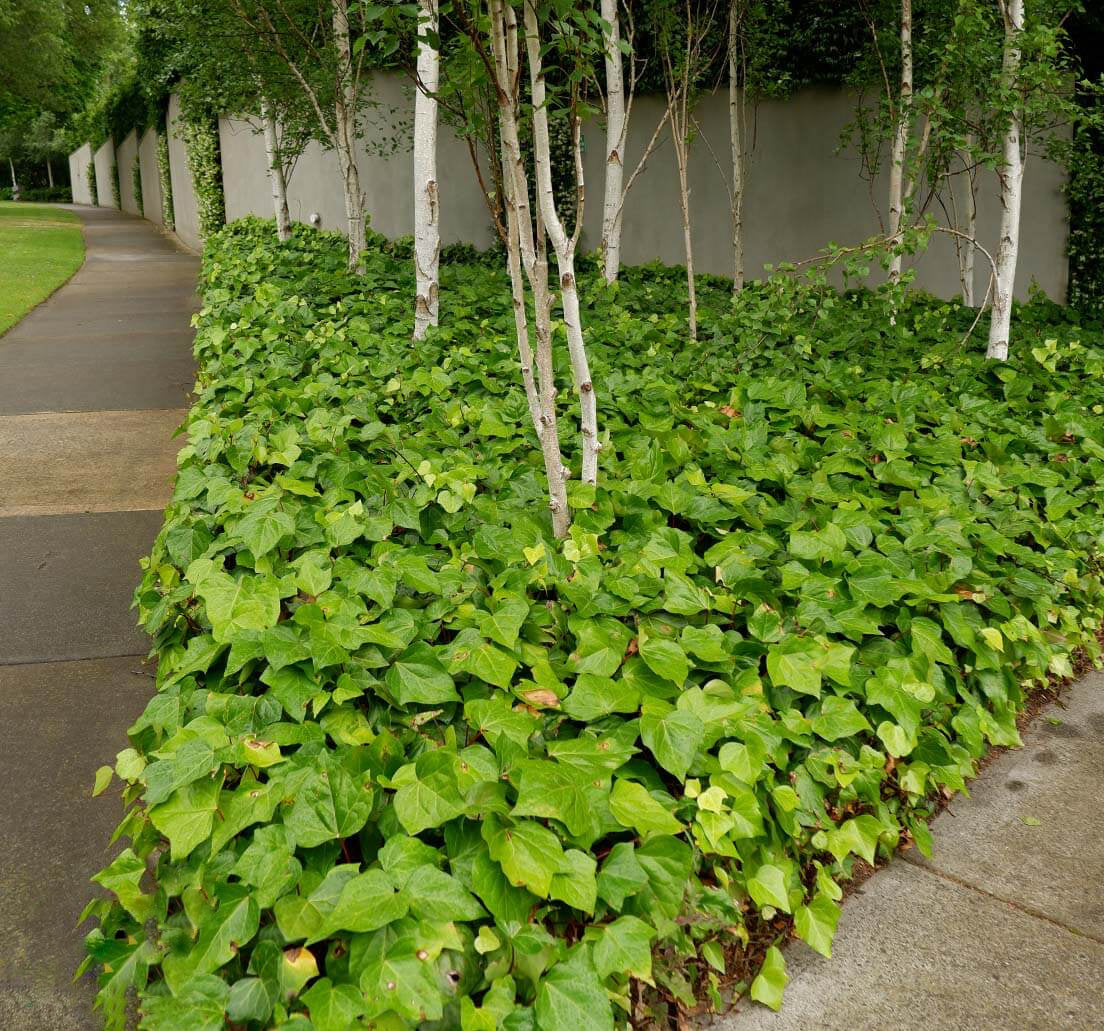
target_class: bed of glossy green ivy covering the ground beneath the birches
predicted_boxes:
[87,222,1104,1031]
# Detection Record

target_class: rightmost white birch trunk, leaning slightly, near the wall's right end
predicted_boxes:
[986,0,1023,361]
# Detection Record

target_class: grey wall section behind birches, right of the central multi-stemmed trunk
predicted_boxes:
[584,89,1066,299]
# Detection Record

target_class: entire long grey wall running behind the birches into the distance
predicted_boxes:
[70,81,1068,300]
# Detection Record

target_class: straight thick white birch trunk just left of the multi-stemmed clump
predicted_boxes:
[414,0,440,340]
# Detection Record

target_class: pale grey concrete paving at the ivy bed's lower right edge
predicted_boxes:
[715,673,1104,1031]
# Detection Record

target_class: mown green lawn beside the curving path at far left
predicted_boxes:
[0,201,84,333]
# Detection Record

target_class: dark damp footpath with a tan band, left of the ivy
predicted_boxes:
[0,206,198,1031]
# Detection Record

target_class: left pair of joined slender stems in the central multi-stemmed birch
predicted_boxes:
[490,0,571,539]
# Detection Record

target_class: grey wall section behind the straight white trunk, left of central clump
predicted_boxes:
[219,75,493,247]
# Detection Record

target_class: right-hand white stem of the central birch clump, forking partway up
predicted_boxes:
[524,3,602,483]
